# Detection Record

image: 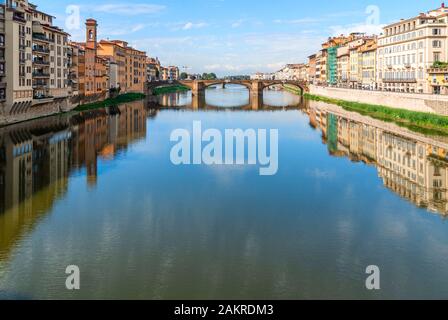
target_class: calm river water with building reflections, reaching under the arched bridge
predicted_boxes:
[0,86,448,299]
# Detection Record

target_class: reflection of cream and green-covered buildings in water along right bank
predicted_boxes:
[307,102,448,215]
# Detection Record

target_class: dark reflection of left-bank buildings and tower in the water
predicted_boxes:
[0,102,146,261]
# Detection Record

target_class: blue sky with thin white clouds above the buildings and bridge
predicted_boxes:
[32,0,441,75]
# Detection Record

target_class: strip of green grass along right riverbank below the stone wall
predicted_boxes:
[305,94,448,135]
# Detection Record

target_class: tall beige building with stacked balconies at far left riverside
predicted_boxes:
[4,0,71,114]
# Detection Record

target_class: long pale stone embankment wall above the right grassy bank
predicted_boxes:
[310,85,448,115]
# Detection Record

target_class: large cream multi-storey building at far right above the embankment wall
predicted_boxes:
[377,6,448,93]
